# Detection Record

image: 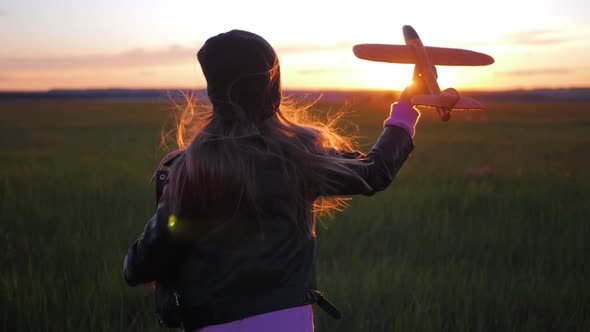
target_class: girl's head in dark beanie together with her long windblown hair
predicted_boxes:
[164,30,368,236]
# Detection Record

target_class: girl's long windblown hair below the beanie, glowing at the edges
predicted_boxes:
[163,93,364,235]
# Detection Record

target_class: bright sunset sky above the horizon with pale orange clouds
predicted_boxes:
[0,0,590,90]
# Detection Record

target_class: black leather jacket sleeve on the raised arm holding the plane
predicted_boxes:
[320,126,414,196]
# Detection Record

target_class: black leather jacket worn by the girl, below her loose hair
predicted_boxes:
[124,126,414,330]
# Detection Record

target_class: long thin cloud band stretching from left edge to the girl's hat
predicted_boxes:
[0,45,196,71]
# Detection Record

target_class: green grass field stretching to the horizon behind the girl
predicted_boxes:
[0,100,590,331]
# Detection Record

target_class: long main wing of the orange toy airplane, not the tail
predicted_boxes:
[352,44,494,66]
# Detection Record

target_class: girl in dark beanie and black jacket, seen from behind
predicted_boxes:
[124,30,424,332]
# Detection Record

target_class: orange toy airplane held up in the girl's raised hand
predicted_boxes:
[353,25,494,121]
